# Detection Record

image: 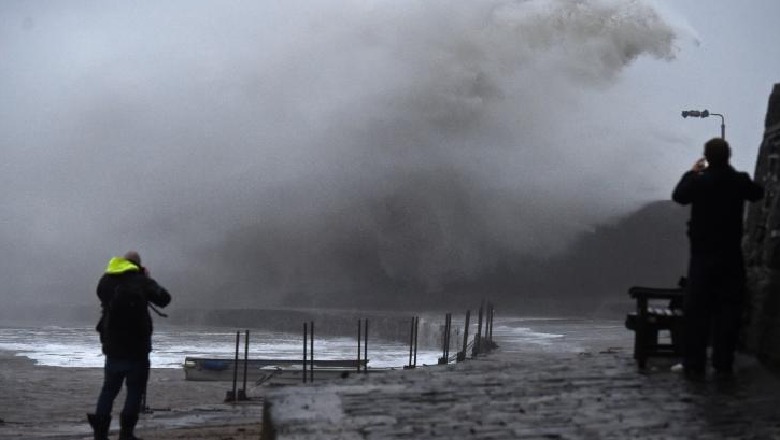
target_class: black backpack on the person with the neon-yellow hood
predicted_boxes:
[100,283,149,351]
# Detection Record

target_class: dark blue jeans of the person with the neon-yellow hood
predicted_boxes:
[95,356,149,415]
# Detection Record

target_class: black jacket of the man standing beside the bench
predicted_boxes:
[672,165,764,255]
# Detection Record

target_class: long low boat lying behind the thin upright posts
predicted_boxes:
[183,356,389,385]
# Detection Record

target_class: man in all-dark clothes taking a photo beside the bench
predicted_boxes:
[672,138,764,379]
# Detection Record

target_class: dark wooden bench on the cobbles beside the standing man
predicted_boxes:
[626,279,684,368]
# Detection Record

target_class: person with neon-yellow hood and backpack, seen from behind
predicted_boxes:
[87,251,171,440]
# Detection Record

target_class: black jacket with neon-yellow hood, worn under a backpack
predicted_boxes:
[96,257,171,359]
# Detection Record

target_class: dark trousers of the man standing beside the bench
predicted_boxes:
[683,253,745,373]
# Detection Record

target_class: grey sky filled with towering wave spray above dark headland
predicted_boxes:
[0,0,780,305]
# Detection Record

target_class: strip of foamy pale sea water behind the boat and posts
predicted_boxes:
[0,317,630,368]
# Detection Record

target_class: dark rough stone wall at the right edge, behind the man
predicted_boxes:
[743,84,780,365]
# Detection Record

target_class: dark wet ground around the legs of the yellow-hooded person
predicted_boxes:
[0,350,265,440]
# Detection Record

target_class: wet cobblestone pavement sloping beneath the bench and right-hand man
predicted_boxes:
[264,338,780,440]
